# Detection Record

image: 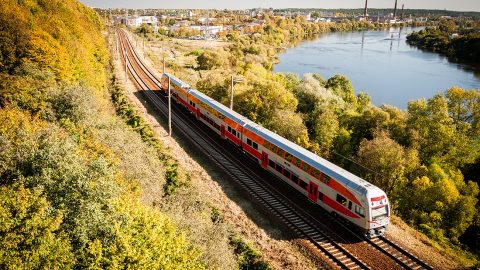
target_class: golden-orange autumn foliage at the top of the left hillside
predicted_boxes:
[0,0,108,90]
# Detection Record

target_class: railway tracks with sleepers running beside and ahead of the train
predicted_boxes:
[117,30,432,269]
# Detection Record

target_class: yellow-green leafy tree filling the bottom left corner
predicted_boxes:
[0,184,75,269]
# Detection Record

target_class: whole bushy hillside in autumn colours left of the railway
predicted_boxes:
[0,0,204,269]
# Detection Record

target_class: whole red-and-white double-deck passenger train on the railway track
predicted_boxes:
[161,73,390,238]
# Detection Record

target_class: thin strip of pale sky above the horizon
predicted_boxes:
[80,0,480,11]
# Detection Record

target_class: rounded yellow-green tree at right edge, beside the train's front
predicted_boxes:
[400,164,479,243]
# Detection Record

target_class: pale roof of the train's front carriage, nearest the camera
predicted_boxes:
[245,121,383,196]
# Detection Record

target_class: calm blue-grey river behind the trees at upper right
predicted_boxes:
[274,27,480,109]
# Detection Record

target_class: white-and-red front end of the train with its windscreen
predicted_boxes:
[366,187,390,238]
